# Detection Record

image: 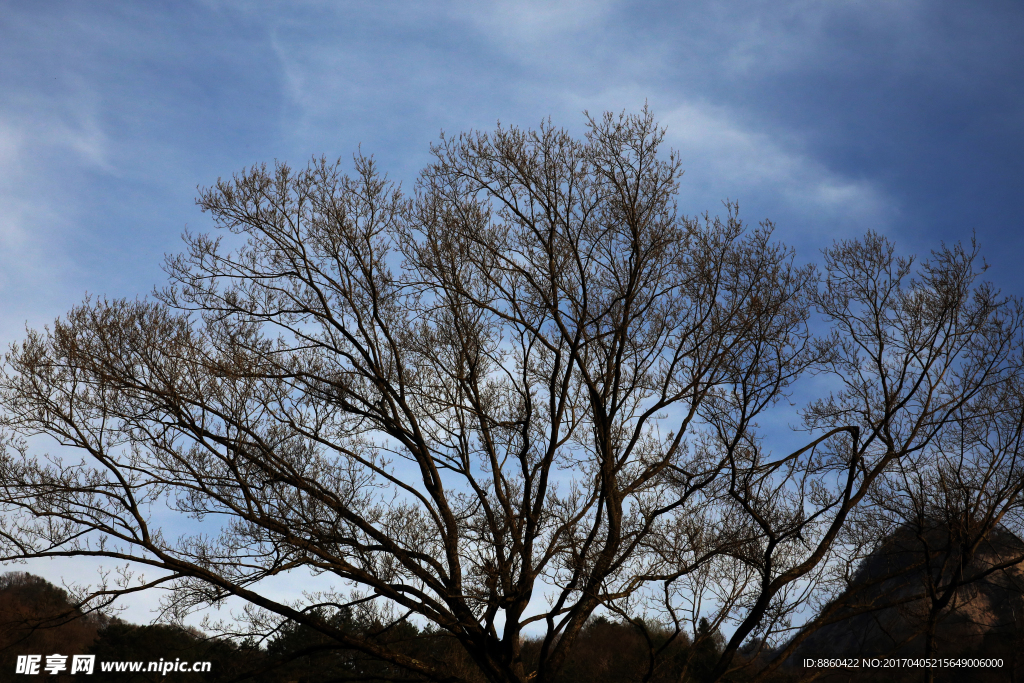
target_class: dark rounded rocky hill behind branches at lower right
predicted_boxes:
[794,523,1024,659]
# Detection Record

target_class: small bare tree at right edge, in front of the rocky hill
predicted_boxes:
[871,383,1024,681]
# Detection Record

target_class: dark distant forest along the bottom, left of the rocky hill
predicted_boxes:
[0,571,722,683]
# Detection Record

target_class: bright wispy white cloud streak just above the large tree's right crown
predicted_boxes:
[558,86,899,239]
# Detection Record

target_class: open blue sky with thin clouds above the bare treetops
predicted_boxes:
[0,0,1024,626]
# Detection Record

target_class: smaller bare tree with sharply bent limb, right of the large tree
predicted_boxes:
[606,234,1024,676]
